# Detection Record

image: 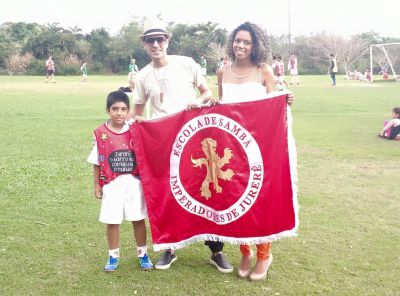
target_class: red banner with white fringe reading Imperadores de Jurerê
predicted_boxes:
[132,95,298,251]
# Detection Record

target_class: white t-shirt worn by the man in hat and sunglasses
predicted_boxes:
[134,55,205,118]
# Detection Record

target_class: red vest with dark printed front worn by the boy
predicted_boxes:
[94,124,139,186]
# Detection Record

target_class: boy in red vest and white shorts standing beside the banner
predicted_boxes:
[88,91,153,272]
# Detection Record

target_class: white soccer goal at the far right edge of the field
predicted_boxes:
[369,43,400,81]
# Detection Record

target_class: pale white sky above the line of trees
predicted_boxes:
[0,0,400,37]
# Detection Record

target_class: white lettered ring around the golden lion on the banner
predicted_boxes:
[170,113,264,225]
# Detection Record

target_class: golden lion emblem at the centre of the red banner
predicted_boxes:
[190,138,235,199]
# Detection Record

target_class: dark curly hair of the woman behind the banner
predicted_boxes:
[227,22,271,66]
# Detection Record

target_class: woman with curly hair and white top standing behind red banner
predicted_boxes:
[218,22,294,281]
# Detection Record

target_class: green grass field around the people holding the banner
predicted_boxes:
[0,76,400,296]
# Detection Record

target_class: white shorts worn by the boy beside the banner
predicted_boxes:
[99,174,147,224]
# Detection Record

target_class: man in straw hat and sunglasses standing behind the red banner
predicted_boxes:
[134,24,233,273]
